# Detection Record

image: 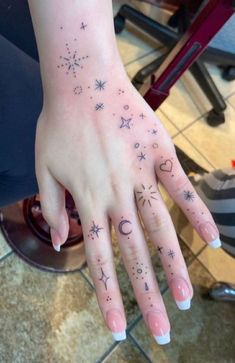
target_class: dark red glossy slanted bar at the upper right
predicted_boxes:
[144,0,235,110]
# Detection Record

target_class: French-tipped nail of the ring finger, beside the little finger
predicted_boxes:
[170,278,191,310]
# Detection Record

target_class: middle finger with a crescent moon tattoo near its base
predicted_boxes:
[110,202,170,344]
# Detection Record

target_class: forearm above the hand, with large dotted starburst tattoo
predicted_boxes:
[29,0,124,102]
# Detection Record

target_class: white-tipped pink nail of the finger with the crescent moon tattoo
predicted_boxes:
[147,312,171,345]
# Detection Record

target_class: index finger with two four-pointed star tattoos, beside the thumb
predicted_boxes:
[76,203,126,341]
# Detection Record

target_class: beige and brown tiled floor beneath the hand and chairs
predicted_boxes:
[0,2,235,363]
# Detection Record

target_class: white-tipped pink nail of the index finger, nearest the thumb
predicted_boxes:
[106,309,126,341]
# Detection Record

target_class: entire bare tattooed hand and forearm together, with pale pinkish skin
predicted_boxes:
[29,0,219,344]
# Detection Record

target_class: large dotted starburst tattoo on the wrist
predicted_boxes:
[57,43,89,78]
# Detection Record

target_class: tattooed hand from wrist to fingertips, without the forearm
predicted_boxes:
[35,69,219,344]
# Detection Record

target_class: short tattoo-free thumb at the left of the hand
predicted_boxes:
[37,168,69,252]
